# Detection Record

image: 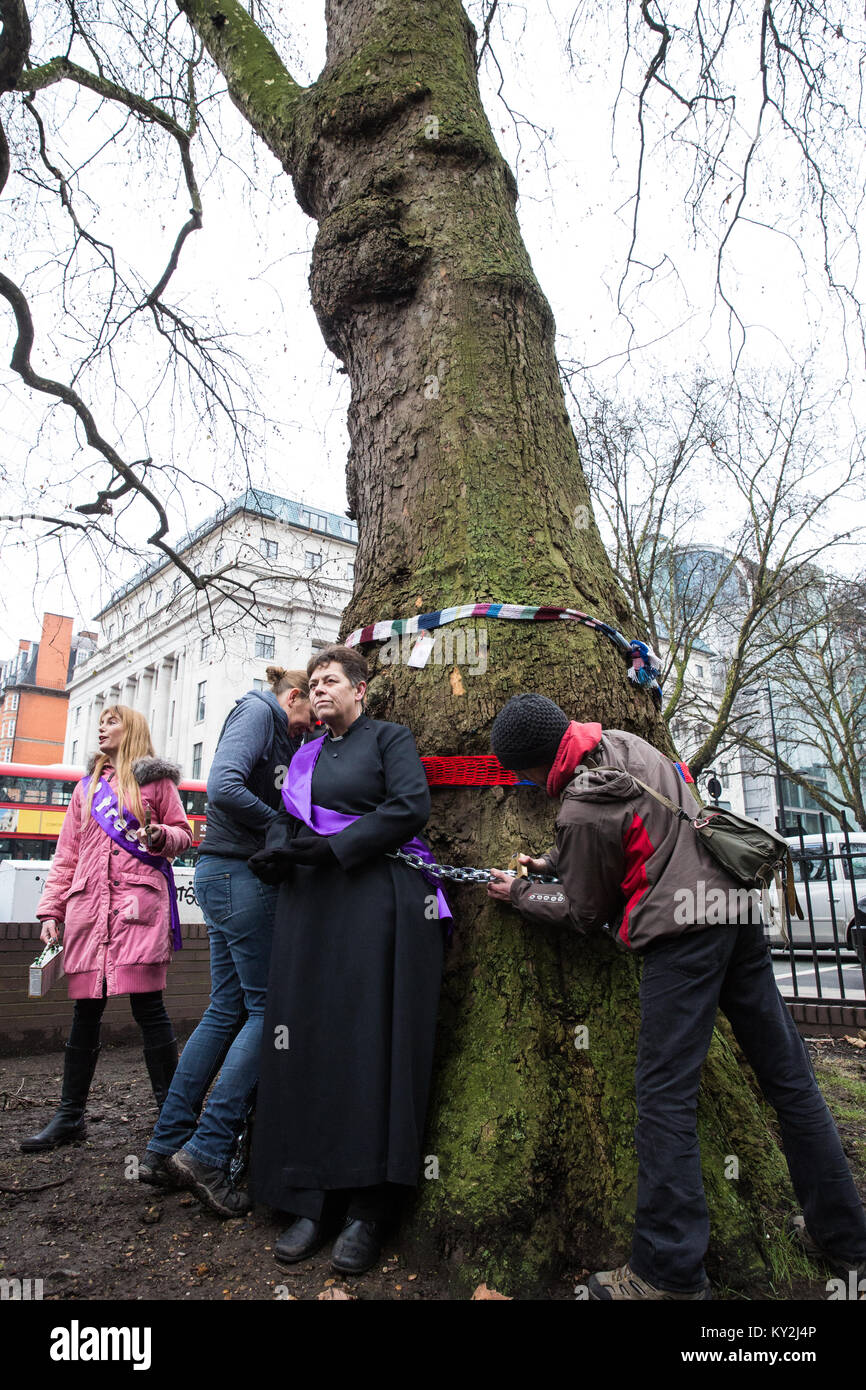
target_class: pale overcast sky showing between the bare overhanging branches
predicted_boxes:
[0,0,866,644]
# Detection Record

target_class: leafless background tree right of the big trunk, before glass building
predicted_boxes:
[580,375,865,776]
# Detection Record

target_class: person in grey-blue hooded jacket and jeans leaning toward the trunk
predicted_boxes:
[139,666,313,1216]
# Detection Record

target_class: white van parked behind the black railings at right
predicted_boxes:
[788,831,866,947]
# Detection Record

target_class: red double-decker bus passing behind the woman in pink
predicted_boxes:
[0,763,207,865]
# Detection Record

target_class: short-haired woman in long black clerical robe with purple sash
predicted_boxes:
[250,646,443,1273]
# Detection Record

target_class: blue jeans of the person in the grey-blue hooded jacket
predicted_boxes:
[147,855,278,1169]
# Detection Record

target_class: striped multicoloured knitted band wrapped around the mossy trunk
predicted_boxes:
[343,603,662,709]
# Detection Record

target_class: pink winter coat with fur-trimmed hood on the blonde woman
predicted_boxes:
[36,758,192,999]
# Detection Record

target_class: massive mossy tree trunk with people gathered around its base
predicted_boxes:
[181,0,784,1293]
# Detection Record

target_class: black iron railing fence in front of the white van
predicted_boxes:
[770,813,866,1004]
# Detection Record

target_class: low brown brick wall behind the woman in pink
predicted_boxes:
[0,922,210,1054]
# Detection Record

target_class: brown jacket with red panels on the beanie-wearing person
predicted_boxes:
[512,723,758,951]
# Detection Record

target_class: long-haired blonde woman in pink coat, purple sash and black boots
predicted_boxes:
[21,705,192,1152]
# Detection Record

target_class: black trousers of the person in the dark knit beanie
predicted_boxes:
[631,923,866,1293]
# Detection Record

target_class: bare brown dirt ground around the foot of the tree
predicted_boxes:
[0,1034,866,1301]
